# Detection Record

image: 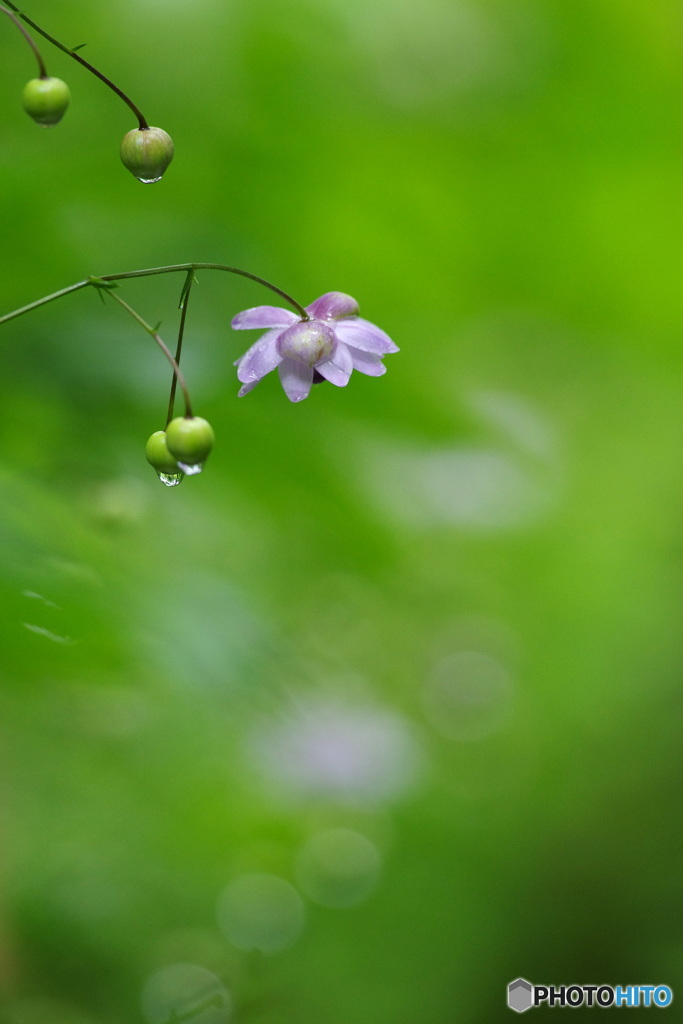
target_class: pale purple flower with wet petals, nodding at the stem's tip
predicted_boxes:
[232,292,398,401]
